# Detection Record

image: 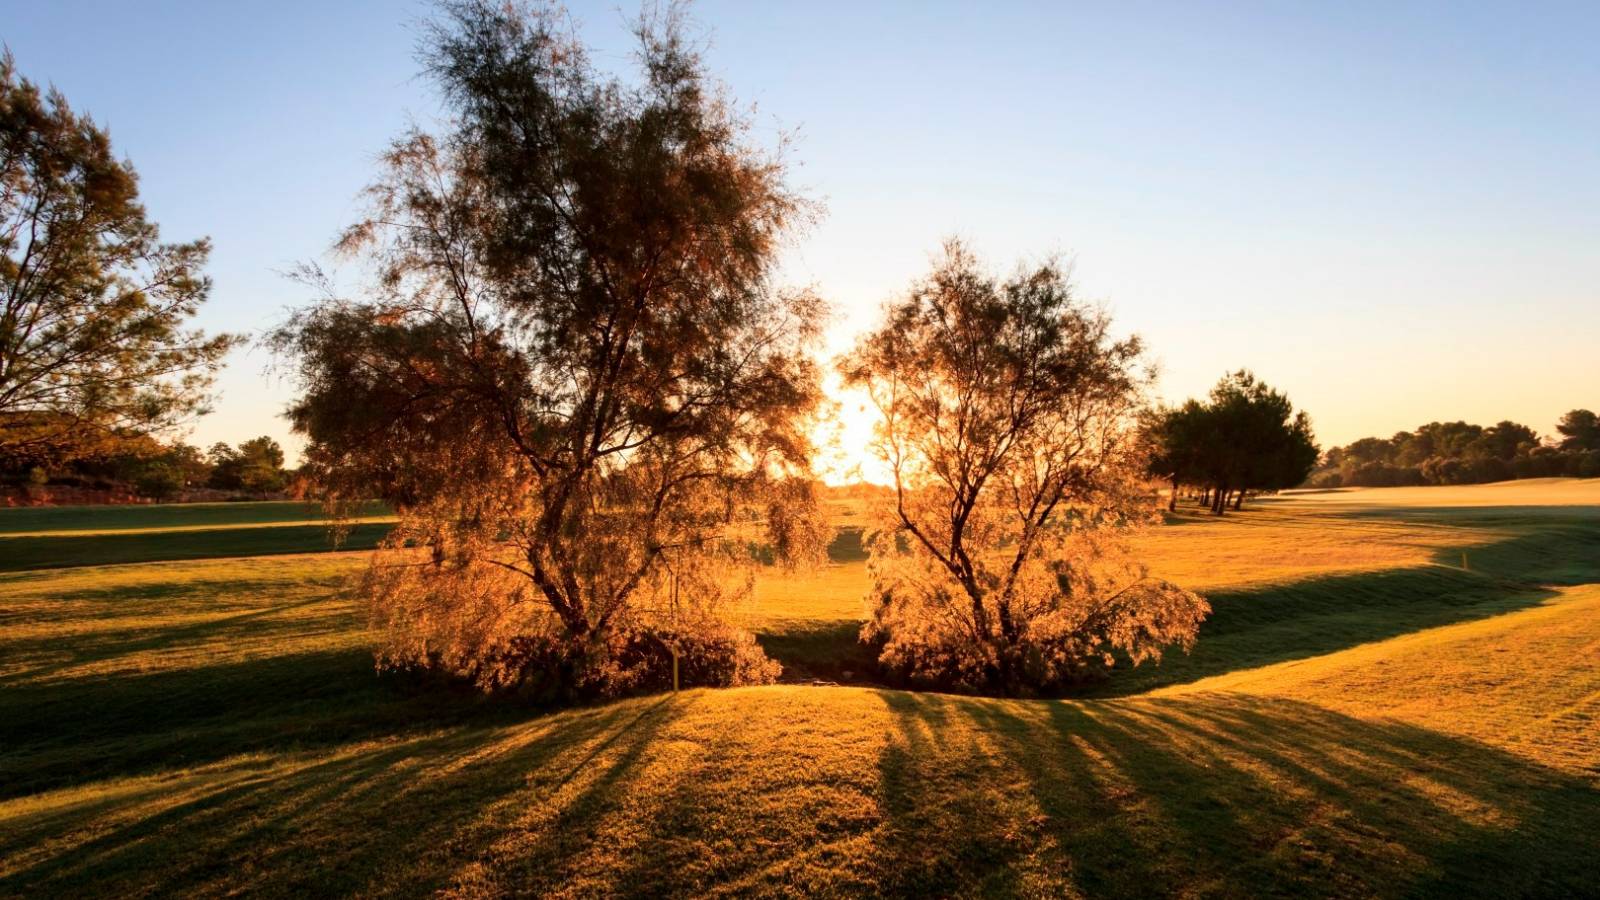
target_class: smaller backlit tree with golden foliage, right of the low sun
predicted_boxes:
[842,242,1210,693]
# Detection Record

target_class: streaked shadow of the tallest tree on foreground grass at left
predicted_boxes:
[0,697,677,897]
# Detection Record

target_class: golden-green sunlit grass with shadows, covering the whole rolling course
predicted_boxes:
[0,484,1600,897]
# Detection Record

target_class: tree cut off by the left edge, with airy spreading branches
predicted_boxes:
[0,54,235,460]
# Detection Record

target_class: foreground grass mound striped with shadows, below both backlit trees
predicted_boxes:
[0,689,1600,897]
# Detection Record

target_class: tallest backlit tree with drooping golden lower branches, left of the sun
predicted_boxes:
[277,0,826,695]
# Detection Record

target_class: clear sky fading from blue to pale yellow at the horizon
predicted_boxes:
[0,0,1600,477]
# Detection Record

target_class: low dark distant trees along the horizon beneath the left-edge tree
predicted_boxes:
[0,434,291,501]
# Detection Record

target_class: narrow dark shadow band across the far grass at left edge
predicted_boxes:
[0,522,392,572]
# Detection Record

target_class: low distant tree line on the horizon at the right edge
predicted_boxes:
[1309,410,1600,487]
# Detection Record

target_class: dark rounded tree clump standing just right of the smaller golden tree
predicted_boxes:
[1146,370,1317,516]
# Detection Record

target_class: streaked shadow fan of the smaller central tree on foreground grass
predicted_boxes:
[880,692,1600,897]
